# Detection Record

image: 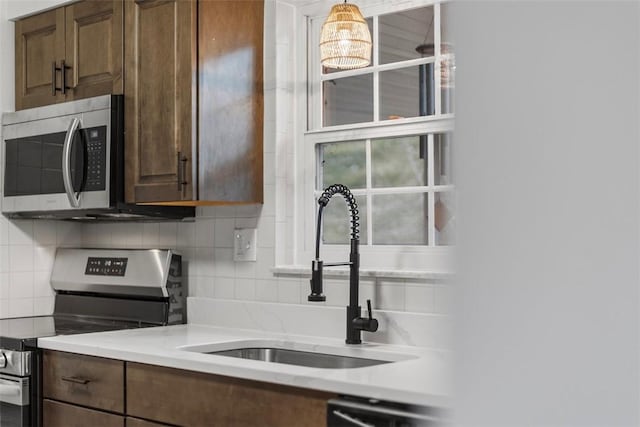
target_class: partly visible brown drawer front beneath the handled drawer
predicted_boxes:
[42,399,124,427]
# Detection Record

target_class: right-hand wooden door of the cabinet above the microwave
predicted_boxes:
[65,0,124,99]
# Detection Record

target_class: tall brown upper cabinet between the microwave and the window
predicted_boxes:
[125,0,264,205]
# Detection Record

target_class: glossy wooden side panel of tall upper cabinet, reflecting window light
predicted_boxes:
[198,0,264,203]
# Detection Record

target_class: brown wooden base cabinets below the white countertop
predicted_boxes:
[43,350,336,427]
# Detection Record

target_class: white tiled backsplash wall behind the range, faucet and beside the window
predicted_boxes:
[0,1,450,347]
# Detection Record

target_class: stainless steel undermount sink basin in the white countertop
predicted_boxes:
[180,340,415,369]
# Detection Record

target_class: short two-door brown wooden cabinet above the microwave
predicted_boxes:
[15,0,123,110]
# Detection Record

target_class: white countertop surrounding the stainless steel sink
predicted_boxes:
[38,324,451,408]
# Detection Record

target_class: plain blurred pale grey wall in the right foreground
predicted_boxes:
[453,1,640,427]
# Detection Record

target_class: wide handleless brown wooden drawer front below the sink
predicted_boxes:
[127,363,335,427]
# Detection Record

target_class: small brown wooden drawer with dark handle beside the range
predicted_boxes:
[43,351,124,413]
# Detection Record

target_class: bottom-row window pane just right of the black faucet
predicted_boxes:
[372,193,429,245]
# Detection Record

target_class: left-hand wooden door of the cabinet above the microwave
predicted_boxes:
[15,8,65,110]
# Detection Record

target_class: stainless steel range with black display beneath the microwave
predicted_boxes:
[0,249,186,427]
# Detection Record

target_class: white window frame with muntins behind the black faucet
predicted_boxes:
[295,0,454,273]
